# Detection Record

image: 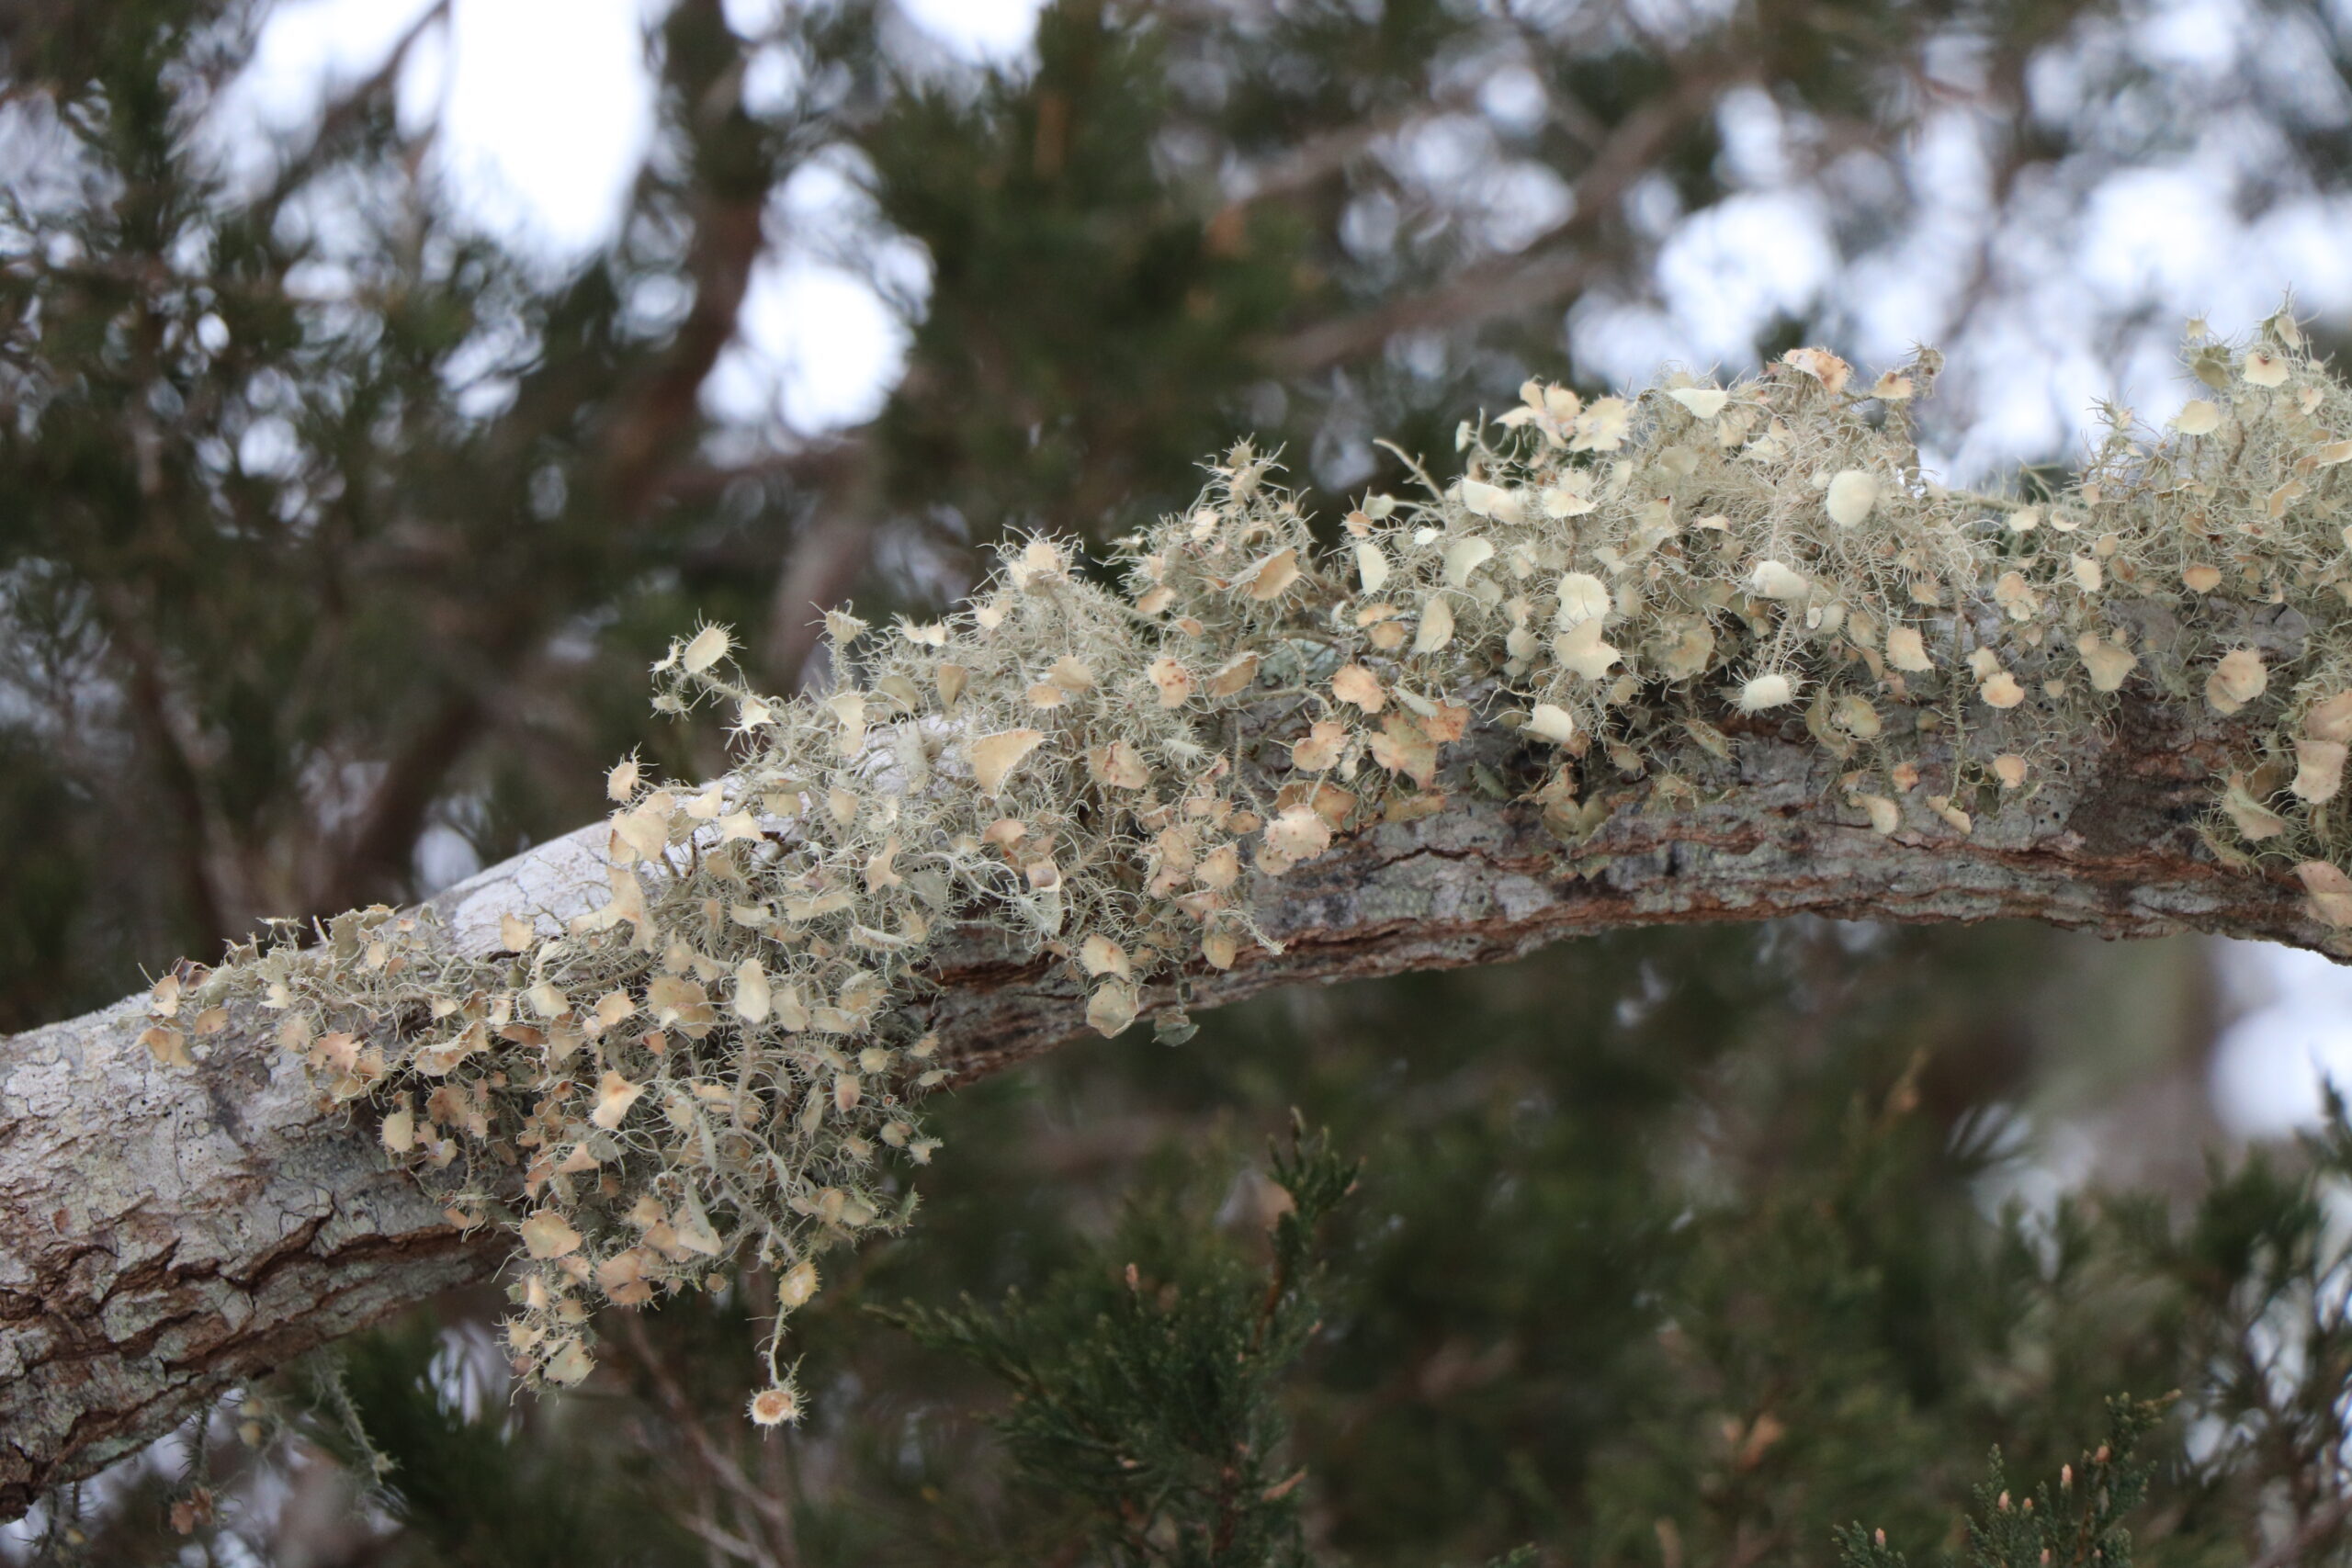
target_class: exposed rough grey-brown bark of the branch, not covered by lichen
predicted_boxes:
[0,701,2352,1518]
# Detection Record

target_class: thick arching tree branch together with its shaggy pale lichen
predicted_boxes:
[0,315,2352,1506]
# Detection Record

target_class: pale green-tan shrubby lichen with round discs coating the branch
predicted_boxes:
[146,312,2352,1422]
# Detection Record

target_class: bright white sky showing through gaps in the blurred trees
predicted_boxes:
[217,0,2352,1134]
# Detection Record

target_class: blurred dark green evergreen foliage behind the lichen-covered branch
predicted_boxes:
[0,0,2352,1568]
